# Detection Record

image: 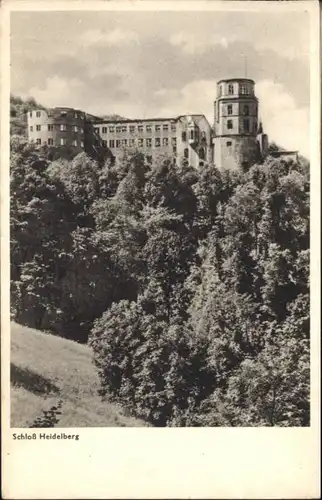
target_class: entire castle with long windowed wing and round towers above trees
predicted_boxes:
[28,78,268,169]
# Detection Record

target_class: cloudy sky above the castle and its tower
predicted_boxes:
[11,11,310,157]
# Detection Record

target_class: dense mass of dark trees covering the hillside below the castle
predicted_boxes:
[11,96,310,426]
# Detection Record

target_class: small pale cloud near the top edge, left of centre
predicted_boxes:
[82,28,139,46]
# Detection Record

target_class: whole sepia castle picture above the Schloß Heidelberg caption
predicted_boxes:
[5,2,311,435]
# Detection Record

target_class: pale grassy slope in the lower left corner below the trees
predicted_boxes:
[11,323,146,427]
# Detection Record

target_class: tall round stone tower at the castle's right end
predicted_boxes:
[214,78,258,169]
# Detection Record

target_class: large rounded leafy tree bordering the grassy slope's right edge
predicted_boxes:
[89,281,216,426]
